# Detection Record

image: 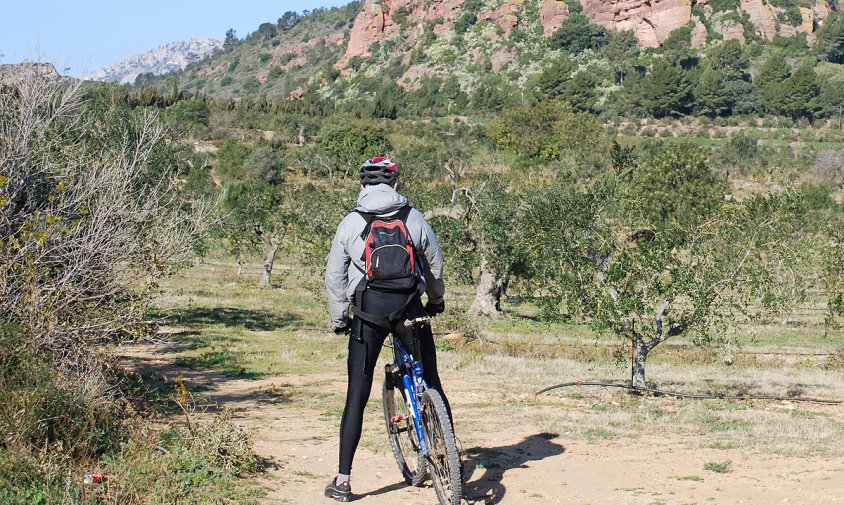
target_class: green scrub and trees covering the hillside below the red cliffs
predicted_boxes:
[145,0,844,121]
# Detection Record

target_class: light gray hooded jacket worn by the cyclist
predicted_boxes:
[325,184,445,328]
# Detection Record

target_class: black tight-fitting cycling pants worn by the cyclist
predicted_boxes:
[340,290,451,475]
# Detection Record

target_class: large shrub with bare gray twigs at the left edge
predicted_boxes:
[0,63,211,369]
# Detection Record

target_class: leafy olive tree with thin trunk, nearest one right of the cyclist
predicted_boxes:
[522,144,815,388]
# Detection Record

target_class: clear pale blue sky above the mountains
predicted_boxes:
[0,0,351,77]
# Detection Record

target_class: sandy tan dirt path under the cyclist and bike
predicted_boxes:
[122,346,844,505]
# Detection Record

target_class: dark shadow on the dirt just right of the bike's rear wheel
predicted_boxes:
[463,433,566,505]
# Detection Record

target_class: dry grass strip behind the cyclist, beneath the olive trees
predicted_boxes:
[148,260,844,459]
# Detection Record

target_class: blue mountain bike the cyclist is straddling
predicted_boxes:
[382,317,462,505]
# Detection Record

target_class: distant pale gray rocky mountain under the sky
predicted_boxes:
[83,38,223,84]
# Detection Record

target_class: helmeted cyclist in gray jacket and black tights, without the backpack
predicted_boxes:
[325,157,451,501]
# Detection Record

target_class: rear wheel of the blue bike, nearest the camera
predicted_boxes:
[420,389,463,505]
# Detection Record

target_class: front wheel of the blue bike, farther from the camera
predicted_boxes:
[381,379,428,487]
